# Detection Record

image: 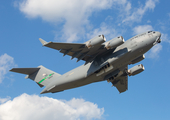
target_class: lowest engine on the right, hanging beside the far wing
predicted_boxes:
[128,64,145,76]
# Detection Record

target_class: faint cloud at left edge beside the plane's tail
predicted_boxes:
[0,53,15,83]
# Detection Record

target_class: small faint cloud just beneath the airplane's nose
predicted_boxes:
[146,44,162,59]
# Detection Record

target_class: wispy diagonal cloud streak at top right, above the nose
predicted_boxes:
[123,0,158,23]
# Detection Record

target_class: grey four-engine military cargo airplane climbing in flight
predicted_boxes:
[10,31,161,94]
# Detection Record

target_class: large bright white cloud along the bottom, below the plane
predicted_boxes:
[0,94,104,120]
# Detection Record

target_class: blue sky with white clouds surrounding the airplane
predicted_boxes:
[0,0,170,120]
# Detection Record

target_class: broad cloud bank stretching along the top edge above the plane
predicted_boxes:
[15,0,158,42]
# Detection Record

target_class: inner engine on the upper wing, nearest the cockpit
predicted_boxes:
[105,36,125,50]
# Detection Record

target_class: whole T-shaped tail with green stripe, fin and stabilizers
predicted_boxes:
[10,65,61,87]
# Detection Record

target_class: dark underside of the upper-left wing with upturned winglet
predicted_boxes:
[39,38,106,63]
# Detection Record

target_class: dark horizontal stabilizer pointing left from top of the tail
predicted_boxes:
[10,68,40,75]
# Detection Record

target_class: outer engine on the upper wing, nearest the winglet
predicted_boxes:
[85,35,106,48]
